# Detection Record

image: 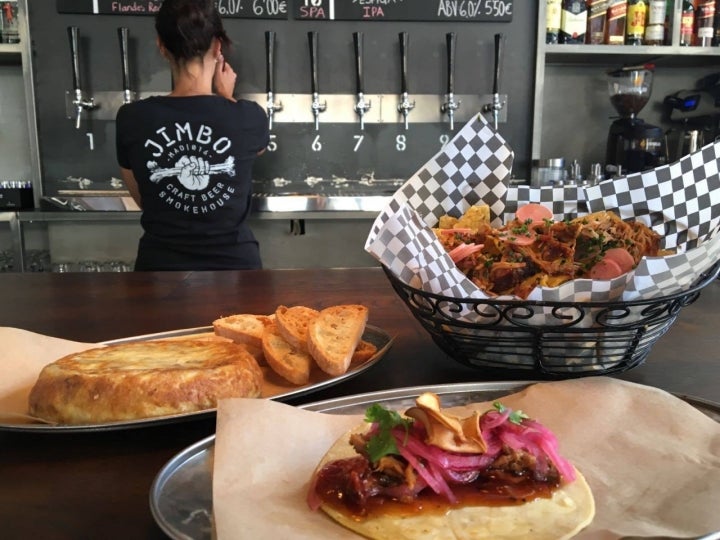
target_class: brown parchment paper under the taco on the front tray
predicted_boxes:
[213,377,720,540]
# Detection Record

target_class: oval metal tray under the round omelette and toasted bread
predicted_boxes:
[0,325,393,433]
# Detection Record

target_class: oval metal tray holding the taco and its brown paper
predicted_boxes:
[150,381,720,540]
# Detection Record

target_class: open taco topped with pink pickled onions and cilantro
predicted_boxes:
[308,393,595,540]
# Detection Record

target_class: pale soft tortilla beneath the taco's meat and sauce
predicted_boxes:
[311,425,595,540]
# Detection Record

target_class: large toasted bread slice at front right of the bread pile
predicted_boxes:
[308,304,369,376]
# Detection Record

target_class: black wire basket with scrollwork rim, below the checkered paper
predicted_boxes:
[383,261,720,378]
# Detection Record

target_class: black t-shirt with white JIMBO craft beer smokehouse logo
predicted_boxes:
[116,95,270,269]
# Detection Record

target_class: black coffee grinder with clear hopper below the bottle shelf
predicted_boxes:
[605,64,667,174]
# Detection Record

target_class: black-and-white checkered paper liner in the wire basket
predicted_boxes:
[365,114,720,304]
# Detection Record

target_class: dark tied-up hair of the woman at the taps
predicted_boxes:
[155,0,230,64]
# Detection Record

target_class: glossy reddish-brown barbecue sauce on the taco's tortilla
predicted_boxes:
[315,458,560,520]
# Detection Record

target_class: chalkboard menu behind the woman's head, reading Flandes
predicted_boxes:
[56,0,289,19]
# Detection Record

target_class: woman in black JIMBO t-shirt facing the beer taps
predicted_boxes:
[116,0,269,270]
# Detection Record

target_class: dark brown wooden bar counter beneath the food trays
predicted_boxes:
[0,268,720,539]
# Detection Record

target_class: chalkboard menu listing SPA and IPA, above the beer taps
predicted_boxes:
[294,0,513,22]
